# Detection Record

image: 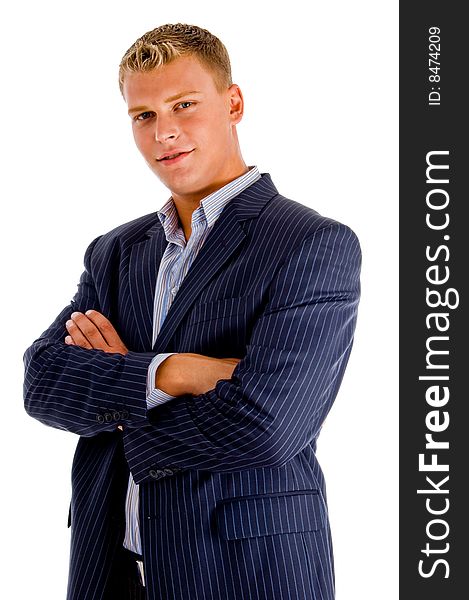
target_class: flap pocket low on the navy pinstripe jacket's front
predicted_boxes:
[215,490,326,540]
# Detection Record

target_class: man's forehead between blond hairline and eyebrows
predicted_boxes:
[123,56,216,104]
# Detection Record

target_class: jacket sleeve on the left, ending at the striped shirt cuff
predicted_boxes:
[23,238,154,436]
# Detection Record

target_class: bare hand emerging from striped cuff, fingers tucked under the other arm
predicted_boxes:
[155,352,241,396]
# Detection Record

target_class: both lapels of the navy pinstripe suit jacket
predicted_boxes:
[129,173,278,353]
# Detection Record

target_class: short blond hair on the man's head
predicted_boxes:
[119,23,233,96]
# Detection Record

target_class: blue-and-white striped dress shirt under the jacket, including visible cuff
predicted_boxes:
[124,166,261,554]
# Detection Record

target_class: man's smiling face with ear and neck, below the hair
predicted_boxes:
[123,56,247,201]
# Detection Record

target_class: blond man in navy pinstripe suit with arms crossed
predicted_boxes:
[25,24,360,600]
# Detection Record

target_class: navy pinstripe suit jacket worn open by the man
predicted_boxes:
[24,174,360,600]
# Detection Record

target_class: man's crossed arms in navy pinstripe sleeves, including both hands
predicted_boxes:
[24,223,361,472]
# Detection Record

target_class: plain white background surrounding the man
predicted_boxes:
[0,0,398,600]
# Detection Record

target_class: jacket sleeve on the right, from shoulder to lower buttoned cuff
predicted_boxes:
[124,223,361,483]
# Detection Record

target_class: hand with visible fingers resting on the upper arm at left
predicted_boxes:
[65,310,128,354]
